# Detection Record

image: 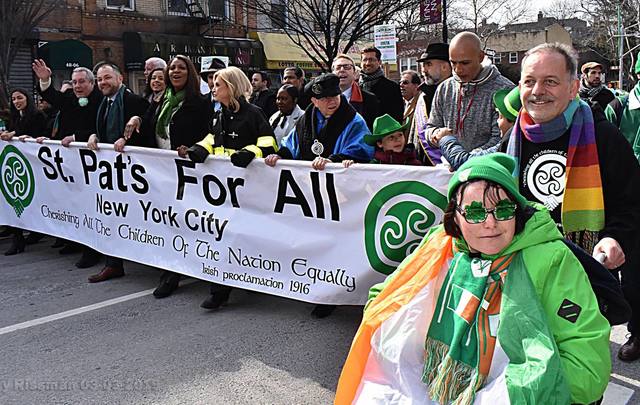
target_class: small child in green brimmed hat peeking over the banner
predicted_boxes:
[342,114,422,167]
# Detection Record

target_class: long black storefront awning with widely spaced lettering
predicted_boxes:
[122,32,264,71]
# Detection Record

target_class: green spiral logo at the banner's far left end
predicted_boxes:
[0,145,35,217]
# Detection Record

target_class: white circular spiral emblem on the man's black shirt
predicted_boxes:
[526,153,567,211]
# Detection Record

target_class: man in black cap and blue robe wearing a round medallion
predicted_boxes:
[265,73,374,318]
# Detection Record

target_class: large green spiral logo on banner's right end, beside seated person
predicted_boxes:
[364,181,447,274]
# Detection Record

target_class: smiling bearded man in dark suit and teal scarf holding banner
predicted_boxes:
[87,63,149,283]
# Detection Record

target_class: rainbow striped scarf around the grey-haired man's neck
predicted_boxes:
[507,99,604,237]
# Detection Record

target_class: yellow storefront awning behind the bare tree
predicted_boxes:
[253,32,364,70]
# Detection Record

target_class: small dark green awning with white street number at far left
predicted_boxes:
[38,39,93,70]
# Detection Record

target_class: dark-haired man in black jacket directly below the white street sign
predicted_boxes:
[360,46,404,122]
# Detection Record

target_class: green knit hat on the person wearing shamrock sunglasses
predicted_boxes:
[447,152,527,207]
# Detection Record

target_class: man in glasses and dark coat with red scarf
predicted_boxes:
[331,54,380,131]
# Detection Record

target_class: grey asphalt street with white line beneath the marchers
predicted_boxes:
[0,238,640,405]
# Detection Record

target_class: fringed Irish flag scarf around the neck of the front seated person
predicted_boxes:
[422,253,513,404]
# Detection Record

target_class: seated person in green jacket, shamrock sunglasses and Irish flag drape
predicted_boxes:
[335,153,611,405]
